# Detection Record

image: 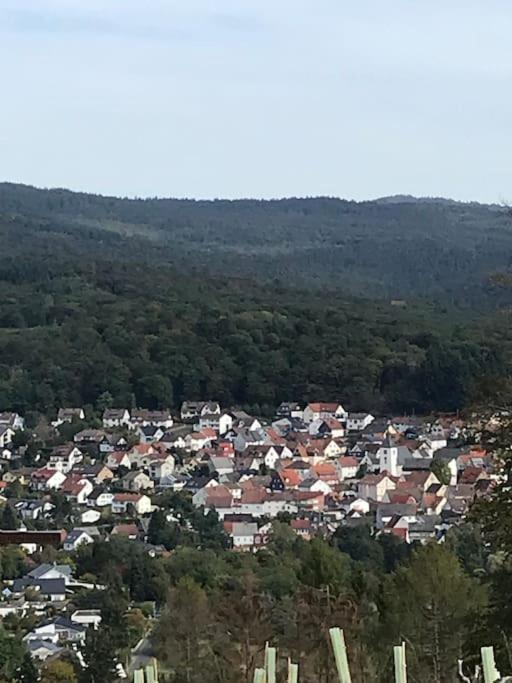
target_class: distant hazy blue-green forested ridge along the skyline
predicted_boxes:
[0,183,512,306]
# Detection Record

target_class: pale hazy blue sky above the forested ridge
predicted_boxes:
[0,0,512,201]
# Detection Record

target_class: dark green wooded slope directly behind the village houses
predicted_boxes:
[0,235,507,415]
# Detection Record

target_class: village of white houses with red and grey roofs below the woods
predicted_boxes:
[0,401,496,663]
